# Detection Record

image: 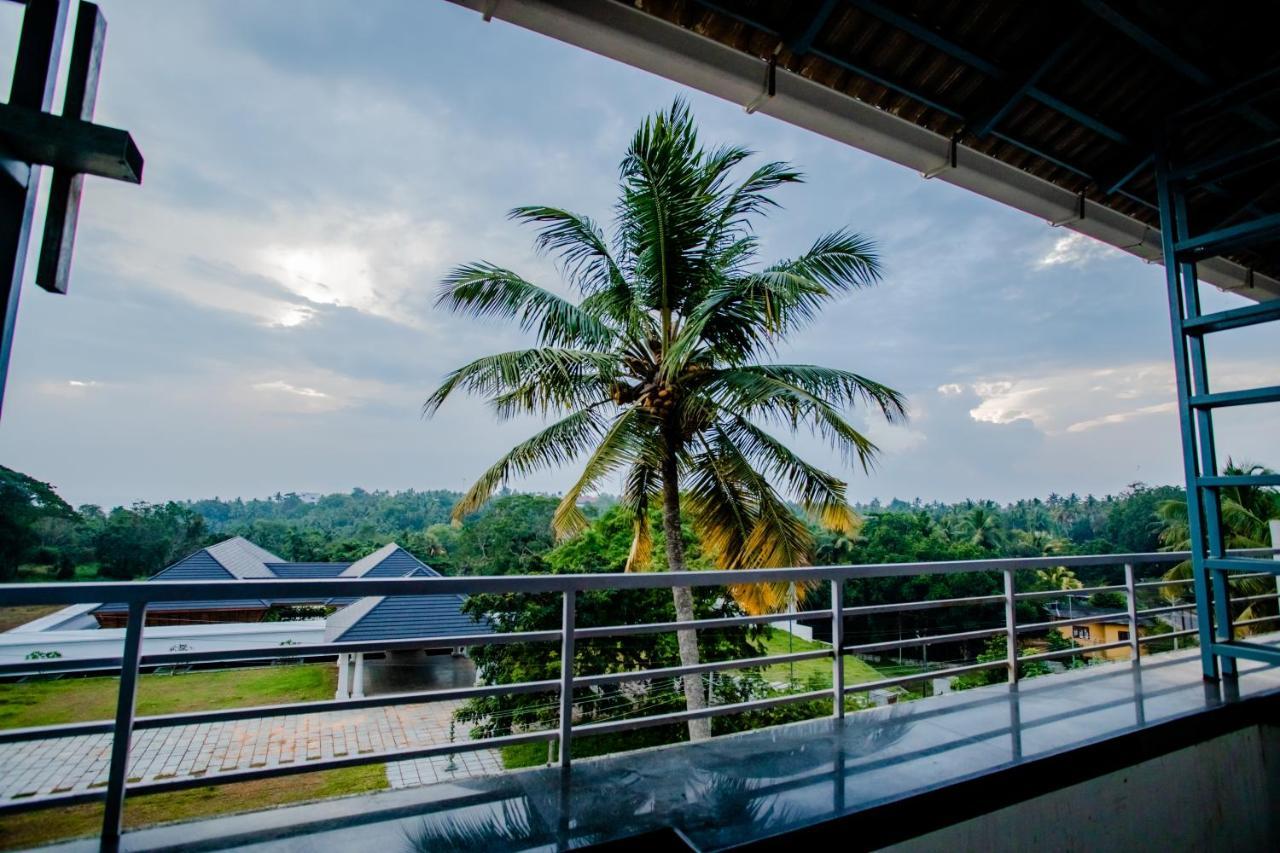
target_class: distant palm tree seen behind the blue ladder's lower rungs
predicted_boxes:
[1156,459,1280,619]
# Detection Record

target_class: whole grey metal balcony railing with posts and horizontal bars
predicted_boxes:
[0,549,1280,849]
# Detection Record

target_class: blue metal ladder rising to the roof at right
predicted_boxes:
[1156,155,1280,680]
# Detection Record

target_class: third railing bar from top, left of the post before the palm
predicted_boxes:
[0,679,559,743]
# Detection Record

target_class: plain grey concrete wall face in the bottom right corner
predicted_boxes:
[886,726,1280,853]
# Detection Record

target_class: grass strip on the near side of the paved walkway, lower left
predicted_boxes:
[0,765,388,850]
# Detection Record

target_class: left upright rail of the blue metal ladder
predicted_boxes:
[1156,154,1219,680]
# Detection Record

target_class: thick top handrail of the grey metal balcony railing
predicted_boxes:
[0,548,1275,607]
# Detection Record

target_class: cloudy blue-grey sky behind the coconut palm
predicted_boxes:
[0,0,1280,506]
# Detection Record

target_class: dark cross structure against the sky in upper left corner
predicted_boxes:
[0,0,142,407]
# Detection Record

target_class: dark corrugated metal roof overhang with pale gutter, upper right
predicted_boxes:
[454,0,1280,300]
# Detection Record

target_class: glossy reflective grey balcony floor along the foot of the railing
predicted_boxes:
[40,637,1280,853]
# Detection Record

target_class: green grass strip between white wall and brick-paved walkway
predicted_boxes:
[0,663,338,729]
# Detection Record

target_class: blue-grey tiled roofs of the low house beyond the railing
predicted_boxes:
[93,537,492,640]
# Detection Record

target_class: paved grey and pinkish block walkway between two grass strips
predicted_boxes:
[0,702,502,800]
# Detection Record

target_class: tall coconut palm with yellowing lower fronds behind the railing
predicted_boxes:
[425,101,906,738]
